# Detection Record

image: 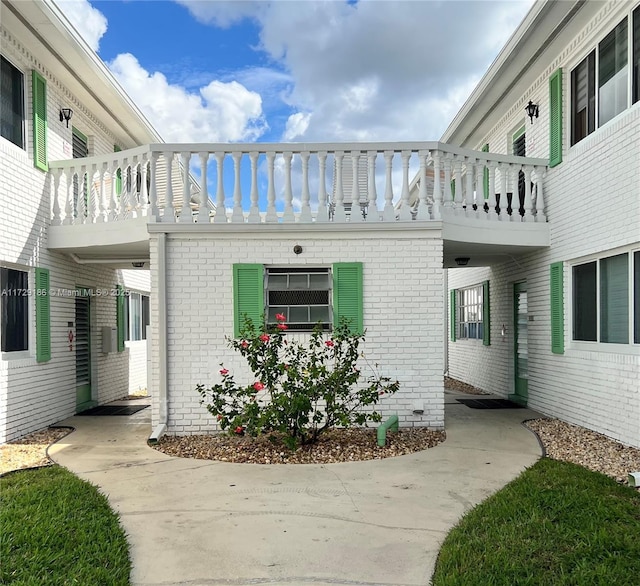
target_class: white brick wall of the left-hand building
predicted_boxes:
[0,29,142,442]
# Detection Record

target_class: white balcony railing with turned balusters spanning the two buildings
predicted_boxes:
[49,142,547,225]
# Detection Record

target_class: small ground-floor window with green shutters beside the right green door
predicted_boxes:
[451,281,490,346]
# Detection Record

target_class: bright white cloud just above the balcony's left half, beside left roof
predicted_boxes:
[109,53,266,142]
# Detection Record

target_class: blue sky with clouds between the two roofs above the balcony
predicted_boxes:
[63,0,532,142]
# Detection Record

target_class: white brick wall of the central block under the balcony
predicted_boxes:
[151,226,444,435]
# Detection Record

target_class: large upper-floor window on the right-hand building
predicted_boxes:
[571,7,640,145]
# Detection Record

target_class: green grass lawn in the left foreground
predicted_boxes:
[0,466,131,586]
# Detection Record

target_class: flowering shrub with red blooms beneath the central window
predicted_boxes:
[196,314,399,449]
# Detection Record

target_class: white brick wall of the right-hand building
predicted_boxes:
[448,3,640,446]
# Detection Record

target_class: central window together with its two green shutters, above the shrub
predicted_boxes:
[233,262,363,337]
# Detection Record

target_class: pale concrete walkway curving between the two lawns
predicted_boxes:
[49,392,541,586]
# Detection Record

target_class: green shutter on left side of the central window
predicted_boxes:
[233,264,264,338]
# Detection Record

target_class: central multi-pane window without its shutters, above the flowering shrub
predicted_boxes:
[266,268,331,331]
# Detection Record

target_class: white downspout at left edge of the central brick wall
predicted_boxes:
[149,232,169,443]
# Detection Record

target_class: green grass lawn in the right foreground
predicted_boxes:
[433,458,640,586]
